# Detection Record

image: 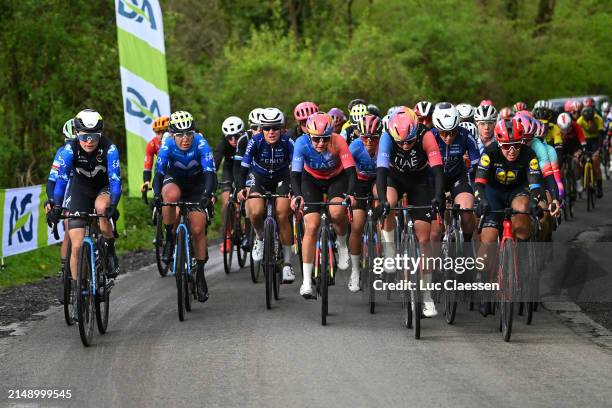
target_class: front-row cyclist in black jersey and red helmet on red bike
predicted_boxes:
[475,120,543,316]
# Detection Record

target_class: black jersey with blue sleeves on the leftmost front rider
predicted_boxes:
[53,136,121,205]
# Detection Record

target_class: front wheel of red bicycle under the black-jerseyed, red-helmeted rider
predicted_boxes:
[498,240,516,342]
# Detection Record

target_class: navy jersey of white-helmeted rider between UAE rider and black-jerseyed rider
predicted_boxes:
[432,127,480,180]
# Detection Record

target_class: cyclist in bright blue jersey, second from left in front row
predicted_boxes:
[153,111,216,302]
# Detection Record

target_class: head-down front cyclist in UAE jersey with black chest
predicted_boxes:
[376,109,444,317]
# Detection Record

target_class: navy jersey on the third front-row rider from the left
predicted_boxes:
[241,133,293,178]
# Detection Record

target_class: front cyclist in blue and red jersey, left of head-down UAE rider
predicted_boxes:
[291,111,358,299]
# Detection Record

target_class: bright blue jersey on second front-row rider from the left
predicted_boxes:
[153,133,216,195]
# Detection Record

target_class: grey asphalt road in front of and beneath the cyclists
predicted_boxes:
[0,182,612,407]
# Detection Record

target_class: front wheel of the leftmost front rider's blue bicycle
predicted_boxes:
[75,241,95,346]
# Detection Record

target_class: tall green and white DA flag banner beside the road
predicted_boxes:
[115,0,170,197]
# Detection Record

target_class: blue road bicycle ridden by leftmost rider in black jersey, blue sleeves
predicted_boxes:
[53,209,115,347]
